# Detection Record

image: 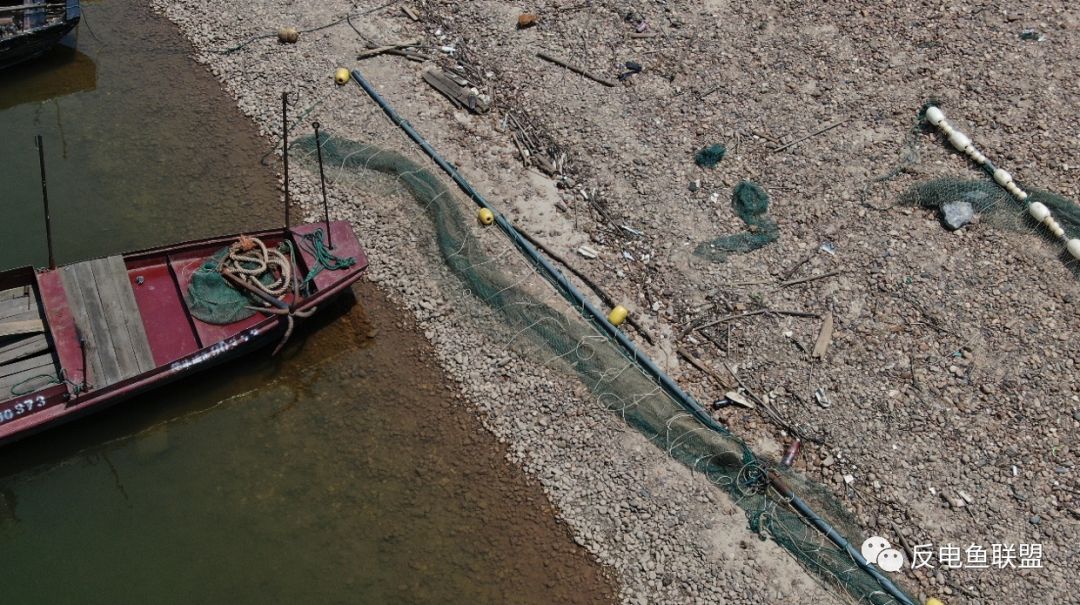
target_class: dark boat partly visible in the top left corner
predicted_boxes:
[0,0,82,69]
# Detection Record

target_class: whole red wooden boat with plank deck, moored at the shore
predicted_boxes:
[0,221,367,444]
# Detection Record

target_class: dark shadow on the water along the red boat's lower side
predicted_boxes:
[0,288,370,484]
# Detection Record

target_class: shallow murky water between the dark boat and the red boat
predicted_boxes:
[0,0,282,269]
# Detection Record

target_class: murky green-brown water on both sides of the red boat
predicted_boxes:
[0,0,612,604]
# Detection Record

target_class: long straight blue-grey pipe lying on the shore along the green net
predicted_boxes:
[349,69,916,605]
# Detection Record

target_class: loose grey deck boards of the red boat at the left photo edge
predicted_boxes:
[0,286,59,400]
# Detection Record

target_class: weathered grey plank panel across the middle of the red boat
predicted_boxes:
[59,256,154,388]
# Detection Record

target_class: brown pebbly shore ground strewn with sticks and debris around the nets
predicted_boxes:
[152,0,1080,604]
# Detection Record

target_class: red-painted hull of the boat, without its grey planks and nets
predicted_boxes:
[0,220,367,445]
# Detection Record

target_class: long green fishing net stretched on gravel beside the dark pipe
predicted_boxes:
[292,133,914,605]
